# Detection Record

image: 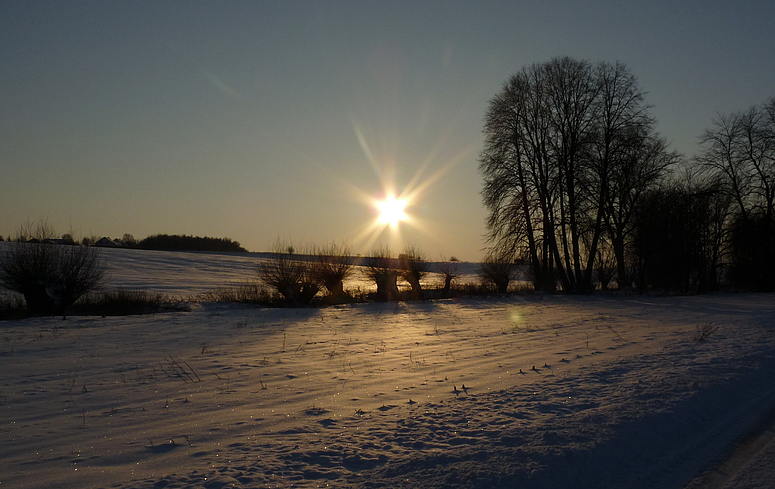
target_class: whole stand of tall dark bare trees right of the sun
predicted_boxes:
[480,58,775,292]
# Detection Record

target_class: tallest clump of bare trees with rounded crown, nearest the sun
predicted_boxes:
[480,58,668,291]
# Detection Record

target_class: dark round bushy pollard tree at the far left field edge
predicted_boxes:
[0,222,103,314]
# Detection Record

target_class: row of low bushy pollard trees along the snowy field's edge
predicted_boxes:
[0,229,514,315]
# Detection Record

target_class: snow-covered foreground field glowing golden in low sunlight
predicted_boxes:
[0,252,775,489]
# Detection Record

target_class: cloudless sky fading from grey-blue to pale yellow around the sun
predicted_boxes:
[0,0,775,260]
